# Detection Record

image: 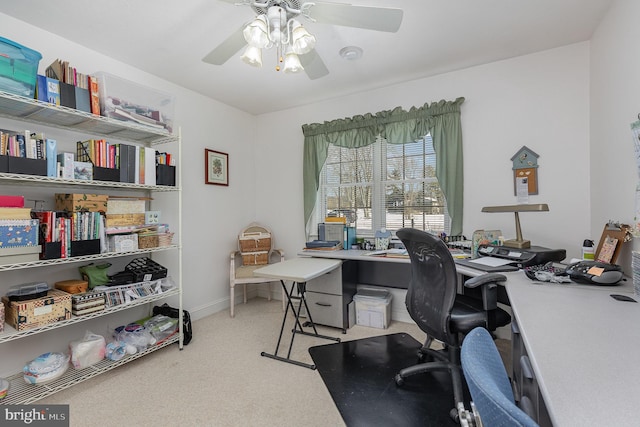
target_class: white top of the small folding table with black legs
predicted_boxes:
[253,258,342,283]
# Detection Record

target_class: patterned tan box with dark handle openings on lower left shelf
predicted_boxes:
[2,289,71,331]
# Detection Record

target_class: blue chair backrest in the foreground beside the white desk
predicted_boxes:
[460,328,538,427]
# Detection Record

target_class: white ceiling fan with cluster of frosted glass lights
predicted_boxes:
[202,0,402,80]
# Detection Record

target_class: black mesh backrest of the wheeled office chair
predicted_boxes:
[396,228,458,343]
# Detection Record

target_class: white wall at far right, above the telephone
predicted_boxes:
[590,0,640,273]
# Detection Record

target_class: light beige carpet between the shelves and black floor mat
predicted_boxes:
[36,298,510,427]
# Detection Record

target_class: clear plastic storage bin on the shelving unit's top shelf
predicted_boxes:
[95,71,175,132]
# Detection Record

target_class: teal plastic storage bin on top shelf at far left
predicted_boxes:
[0,37,42,99]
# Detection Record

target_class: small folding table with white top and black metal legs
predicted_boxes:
[253,258,342,369]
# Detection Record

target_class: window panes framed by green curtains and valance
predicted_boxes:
[316,135,450,235]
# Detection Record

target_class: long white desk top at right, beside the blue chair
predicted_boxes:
[506,272,640,426]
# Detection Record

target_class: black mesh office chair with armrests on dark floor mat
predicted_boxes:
[395,228,511,421]
